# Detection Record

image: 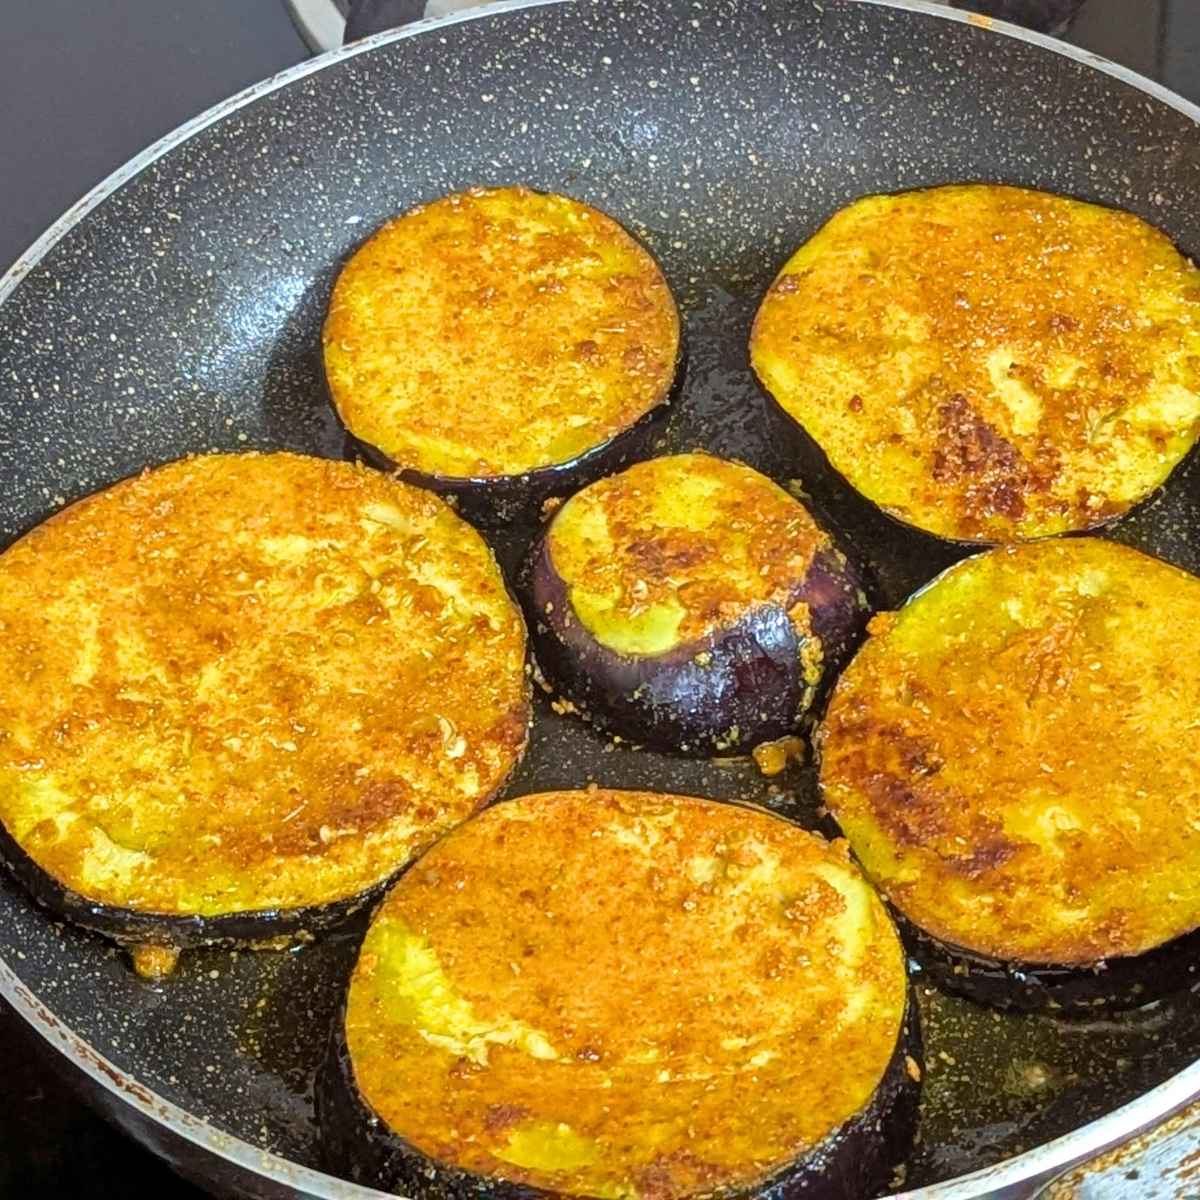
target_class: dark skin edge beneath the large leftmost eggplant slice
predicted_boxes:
[0,824,398,950]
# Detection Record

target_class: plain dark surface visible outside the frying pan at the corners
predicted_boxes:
[0,0,1200,1200]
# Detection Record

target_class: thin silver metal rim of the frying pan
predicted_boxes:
[0,0,1200,1200]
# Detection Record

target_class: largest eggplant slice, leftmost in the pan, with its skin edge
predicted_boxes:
[0,454,529,971]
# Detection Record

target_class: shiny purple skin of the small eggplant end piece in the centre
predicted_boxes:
[517,534,868,756]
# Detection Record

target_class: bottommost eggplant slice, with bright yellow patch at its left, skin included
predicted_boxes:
[319,791,920,1200]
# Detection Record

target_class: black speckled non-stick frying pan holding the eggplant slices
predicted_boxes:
[0,0,1200,1200]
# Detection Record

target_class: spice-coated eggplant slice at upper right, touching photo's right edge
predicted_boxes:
[751,185,1200,542]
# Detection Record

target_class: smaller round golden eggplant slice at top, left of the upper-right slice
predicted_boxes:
[324,187,680,516]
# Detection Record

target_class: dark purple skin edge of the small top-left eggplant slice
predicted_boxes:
[336,343,686,529]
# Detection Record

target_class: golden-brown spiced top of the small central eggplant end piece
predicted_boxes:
[548,452,829,654]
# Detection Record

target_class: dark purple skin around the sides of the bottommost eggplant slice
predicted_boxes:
[316,988,924,1200]
